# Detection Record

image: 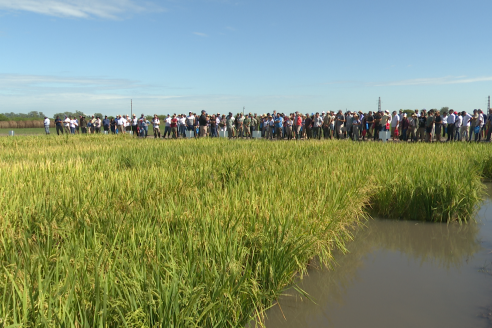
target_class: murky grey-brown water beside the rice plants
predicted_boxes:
[265,185,492,328]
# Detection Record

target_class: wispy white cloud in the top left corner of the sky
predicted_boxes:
[0,0,164,19]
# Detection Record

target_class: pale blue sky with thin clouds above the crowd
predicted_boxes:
[0,0,492,115]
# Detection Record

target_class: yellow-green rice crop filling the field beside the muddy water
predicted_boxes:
[0,135,492,327]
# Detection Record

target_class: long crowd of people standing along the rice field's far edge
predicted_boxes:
[45,109,492,142]
